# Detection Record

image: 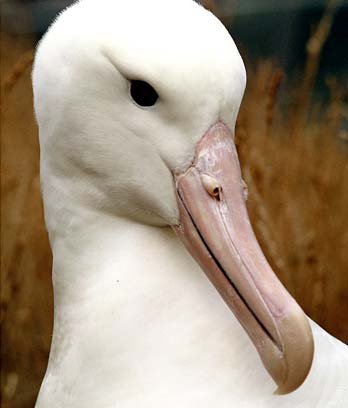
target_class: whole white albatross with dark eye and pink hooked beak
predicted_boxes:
[33,0,348,408]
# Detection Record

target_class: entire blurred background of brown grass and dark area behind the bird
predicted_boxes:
[0,0,348,408]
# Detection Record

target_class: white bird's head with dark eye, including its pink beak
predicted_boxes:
[33,0,313,392]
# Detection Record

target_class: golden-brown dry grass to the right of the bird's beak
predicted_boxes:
[237,63,348,342]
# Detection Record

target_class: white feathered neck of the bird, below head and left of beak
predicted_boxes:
[38,209,272,407]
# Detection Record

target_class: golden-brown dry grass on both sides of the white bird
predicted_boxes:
[1,4,348,408]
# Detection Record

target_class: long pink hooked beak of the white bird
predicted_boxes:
[175,122,314,394]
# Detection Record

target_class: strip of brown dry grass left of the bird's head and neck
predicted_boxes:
[1,35,53,408]
